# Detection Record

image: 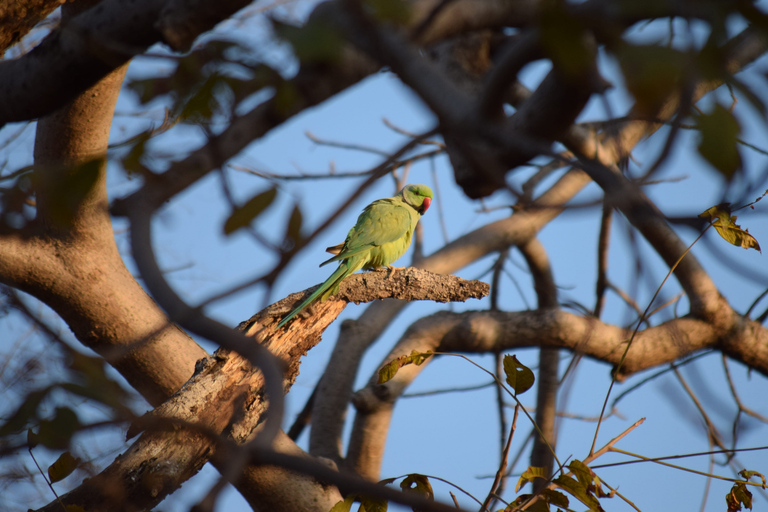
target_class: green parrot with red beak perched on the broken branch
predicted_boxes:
[277,185,432,329]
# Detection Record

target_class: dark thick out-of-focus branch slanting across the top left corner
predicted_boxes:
[0,0,266,126]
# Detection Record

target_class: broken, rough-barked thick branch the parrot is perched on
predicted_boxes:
[37,268,489,512]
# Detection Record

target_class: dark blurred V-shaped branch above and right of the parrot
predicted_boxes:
[327,2,600,198]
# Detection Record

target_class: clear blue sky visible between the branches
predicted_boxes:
[0,2,768,511]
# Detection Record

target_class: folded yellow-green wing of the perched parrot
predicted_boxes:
[320,199,413,266]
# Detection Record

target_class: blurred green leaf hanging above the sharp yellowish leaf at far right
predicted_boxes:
[696,103,741,180]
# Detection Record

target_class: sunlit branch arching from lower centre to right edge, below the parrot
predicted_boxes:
[349,309,768,482]
